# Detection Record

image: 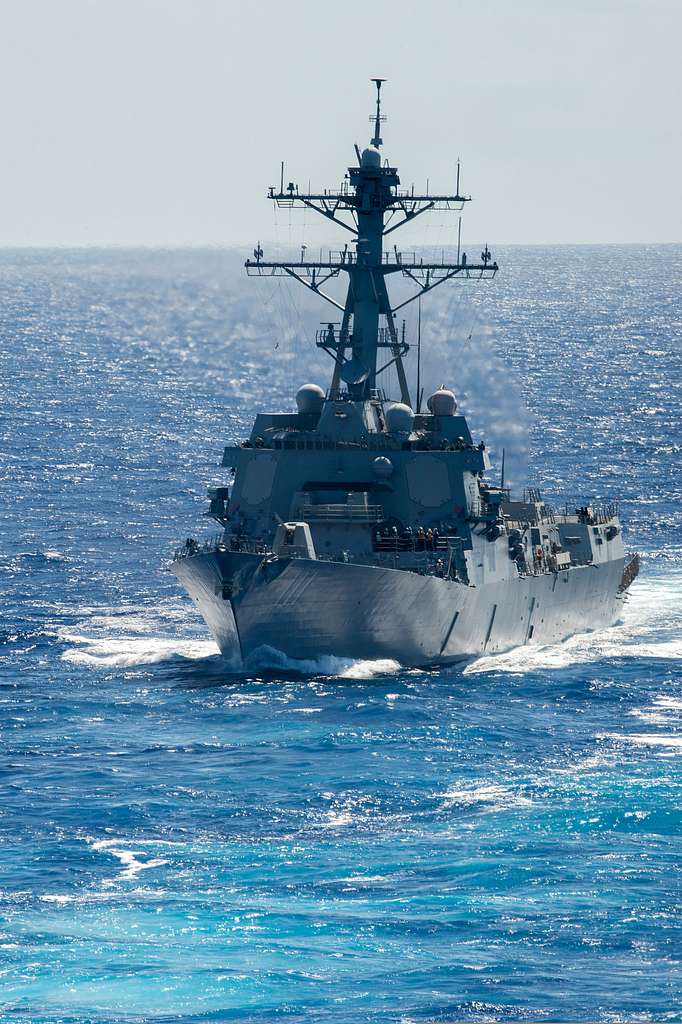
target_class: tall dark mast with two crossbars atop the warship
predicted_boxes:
[246,78,498,406]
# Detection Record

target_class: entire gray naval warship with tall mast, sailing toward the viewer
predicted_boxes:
[170,79,639,666]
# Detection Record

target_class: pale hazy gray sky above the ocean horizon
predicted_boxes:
[0,0,682,246]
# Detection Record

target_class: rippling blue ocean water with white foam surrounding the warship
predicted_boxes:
[0,247,682,1024]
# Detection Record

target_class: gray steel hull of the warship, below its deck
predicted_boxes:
[171,551,626,666]
